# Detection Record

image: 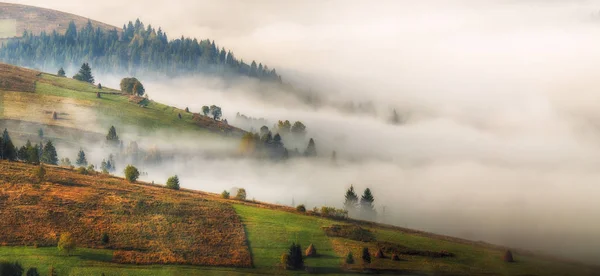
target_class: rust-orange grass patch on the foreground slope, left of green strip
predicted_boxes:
[0,162,252,267]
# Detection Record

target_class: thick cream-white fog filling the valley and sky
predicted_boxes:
[7,0,600,263]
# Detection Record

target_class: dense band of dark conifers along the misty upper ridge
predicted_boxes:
[0,19,281,82]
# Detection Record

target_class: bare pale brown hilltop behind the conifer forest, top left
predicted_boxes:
[0,3,116,39]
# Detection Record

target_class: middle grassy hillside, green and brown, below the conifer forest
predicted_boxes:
[0,63,244,140]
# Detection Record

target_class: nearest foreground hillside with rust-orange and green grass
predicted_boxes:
[0,161,598,275]
